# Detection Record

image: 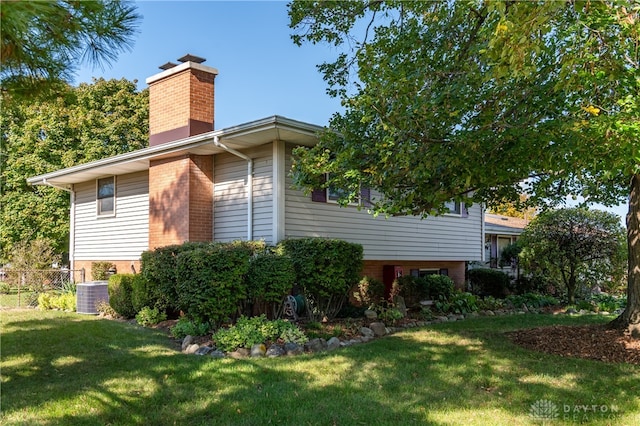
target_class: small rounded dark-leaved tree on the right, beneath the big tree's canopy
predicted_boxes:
[519,208,625,304]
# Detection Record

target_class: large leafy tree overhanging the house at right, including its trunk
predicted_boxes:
[289,0,640,328]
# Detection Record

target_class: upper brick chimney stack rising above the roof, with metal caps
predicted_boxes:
[147,55,218,146]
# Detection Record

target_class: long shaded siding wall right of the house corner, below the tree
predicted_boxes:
[285,146,483,261]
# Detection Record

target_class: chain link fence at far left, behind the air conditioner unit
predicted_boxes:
[0,269,85,308]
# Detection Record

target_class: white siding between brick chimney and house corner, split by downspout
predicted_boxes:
[213,143,273,243]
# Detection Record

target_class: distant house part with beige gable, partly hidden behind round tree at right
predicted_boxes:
[484,213,529,273]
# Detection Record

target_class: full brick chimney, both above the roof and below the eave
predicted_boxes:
[147,55,218,249]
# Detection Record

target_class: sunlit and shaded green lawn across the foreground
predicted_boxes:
[0,310,640,425]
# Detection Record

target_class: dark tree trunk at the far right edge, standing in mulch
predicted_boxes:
[610,173,640,338]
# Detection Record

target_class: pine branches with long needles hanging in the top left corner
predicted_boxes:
[0,0,140,101]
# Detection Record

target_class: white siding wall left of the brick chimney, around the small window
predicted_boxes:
[74,171,149,260]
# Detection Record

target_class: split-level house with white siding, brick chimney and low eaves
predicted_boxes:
[28,55,484,287]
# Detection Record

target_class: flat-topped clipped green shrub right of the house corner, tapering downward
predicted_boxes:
[278,238,363,319]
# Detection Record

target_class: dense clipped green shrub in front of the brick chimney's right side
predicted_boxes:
[176,243,252,324]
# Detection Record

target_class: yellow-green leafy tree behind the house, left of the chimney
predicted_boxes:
[0,79,149,261]
